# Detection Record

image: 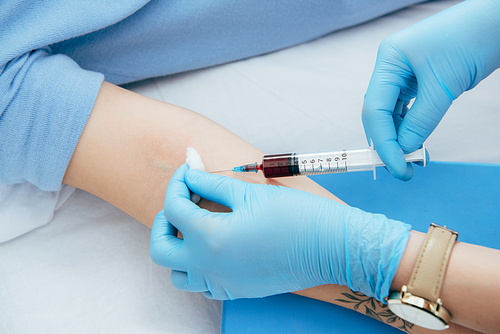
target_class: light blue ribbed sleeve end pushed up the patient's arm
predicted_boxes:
[0,49,104,191]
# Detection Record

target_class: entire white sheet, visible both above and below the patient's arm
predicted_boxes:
[0,1,500,334]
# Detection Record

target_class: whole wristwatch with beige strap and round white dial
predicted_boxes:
[387,223,458,330]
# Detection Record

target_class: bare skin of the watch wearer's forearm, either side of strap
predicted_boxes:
[391,231,500,333]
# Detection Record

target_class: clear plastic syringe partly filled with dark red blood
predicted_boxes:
[214,146,427,179]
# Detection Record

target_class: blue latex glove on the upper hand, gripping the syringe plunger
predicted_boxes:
[363,0,500,180]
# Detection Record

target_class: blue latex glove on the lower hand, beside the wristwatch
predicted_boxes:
[151,165,410,300]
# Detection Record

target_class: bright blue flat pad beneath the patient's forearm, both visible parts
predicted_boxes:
[222,162,500,334]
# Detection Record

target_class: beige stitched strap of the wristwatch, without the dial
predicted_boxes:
[407,223,458,302]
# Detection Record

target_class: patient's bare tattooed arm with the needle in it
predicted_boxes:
[64,83,496,333]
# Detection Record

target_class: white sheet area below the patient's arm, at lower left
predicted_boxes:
[0,190,221,334]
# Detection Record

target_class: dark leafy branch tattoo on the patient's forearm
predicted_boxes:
[335,290,413,333]
